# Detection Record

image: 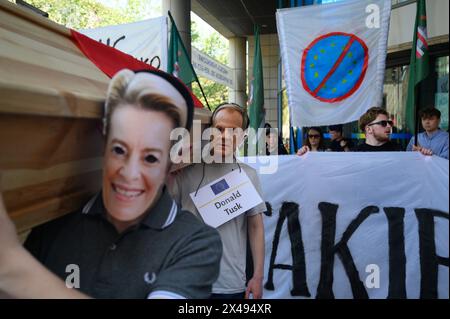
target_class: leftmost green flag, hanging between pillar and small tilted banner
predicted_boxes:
[167,14,197,84]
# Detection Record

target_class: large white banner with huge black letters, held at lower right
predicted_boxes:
[244,152,449,298]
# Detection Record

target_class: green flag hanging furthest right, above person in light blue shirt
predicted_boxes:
[406,0,429,132]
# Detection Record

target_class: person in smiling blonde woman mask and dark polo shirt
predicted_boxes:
[0,69,222,299]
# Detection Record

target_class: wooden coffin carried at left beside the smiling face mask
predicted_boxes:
[0,0,210,238]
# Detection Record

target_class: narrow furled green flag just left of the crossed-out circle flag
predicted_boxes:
[248,27,265,155]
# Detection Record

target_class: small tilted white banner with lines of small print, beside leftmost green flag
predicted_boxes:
[192,47,235,89]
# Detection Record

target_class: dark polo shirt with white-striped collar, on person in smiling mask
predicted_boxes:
[25,189,222,299]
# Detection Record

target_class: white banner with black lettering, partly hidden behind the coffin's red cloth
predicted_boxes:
[79,17,167,70]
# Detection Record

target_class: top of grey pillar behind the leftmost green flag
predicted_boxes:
[162,0,191,57]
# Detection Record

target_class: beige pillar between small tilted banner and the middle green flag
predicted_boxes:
[228,37,247,106]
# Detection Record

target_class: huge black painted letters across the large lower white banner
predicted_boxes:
[264,202,449,299]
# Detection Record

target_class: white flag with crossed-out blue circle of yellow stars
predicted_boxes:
[276,0,391,127]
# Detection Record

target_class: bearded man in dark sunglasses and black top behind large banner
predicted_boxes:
[353,107,402,152]
